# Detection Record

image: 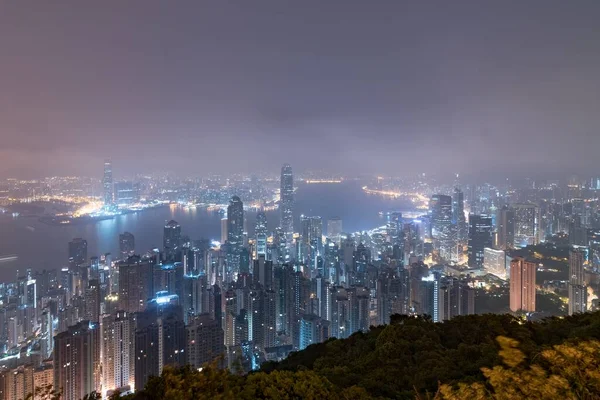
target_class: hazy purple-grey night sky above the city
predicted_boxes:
[0,0,600,178]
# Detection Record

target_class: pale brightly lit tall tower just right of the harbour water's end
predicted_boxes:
[429,194,456,261]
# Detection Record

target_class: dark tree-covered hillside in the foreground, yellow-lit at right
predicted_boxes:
[131,313,600,399]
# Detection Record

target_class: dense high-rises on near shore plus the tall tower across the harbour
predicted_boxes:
[0,170,600,400]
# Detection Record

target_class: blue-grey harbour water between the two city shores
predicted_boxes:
[0,183,410,281]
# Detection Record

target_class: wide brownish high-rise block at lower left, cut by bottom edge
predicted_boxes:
[54,321,101,400]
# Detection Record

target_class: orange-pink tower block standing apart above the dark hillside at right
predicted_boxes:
[510,257,537,312]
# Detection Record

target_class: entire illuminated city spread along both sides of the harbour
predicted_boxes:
[0,161,600,400]
